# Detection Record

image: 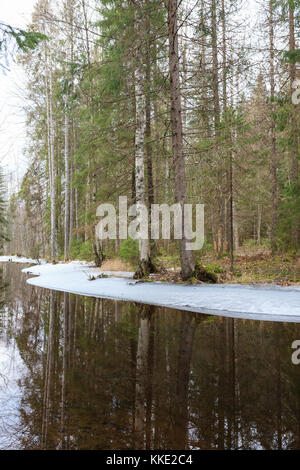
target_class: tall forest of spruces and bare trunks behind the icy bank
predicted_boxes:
[2,0,300,282]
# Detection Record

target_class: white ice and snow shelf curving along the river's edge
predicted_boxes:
[17,262,300,322]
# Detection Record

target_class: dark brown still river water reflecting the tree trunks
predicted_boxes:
[0,264,300,450]
